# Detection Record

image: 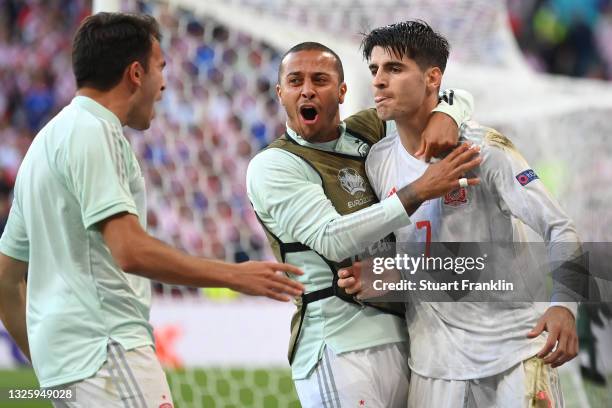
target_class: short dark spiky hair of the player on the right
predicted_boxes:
[361,20,449,72]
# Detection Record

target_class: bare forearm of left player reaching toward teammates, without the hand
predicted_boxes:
[122,235,237,288]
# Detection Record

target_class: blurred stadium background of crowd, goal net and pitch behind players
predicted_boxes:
[0,0,612,407]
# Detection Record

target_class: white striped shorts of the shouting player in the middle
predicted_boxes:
[295,343,410,408]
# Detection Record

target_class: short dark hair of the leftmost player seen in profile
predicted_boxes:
[72,13,161,91]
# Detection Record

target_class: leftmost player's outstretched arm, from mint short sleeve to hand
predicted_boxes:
[64,118,303,301]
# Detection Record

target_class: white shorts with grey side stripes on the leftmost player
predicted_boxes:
[53,342,174,408]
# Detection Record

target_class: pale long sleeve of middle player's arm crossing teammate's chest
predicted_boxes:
[247,149,410,261]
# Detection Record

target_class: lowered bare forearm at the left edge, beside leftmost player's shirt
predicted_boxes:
[0,280,30,360]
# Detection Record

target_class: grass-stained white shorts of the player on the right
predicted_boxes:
[408,357,564,408]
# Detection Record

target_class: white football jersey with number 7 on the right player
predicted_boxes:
[366,122,579,380]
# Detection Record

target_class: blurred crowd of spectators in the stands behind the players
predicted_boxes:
[0,0,612,268]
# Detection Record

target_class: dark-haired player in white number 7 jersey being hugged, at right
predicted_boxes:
[339,21,579,408]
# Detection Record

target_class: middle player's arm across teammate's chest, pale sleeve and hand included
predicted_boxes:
[247,144,480,261]
